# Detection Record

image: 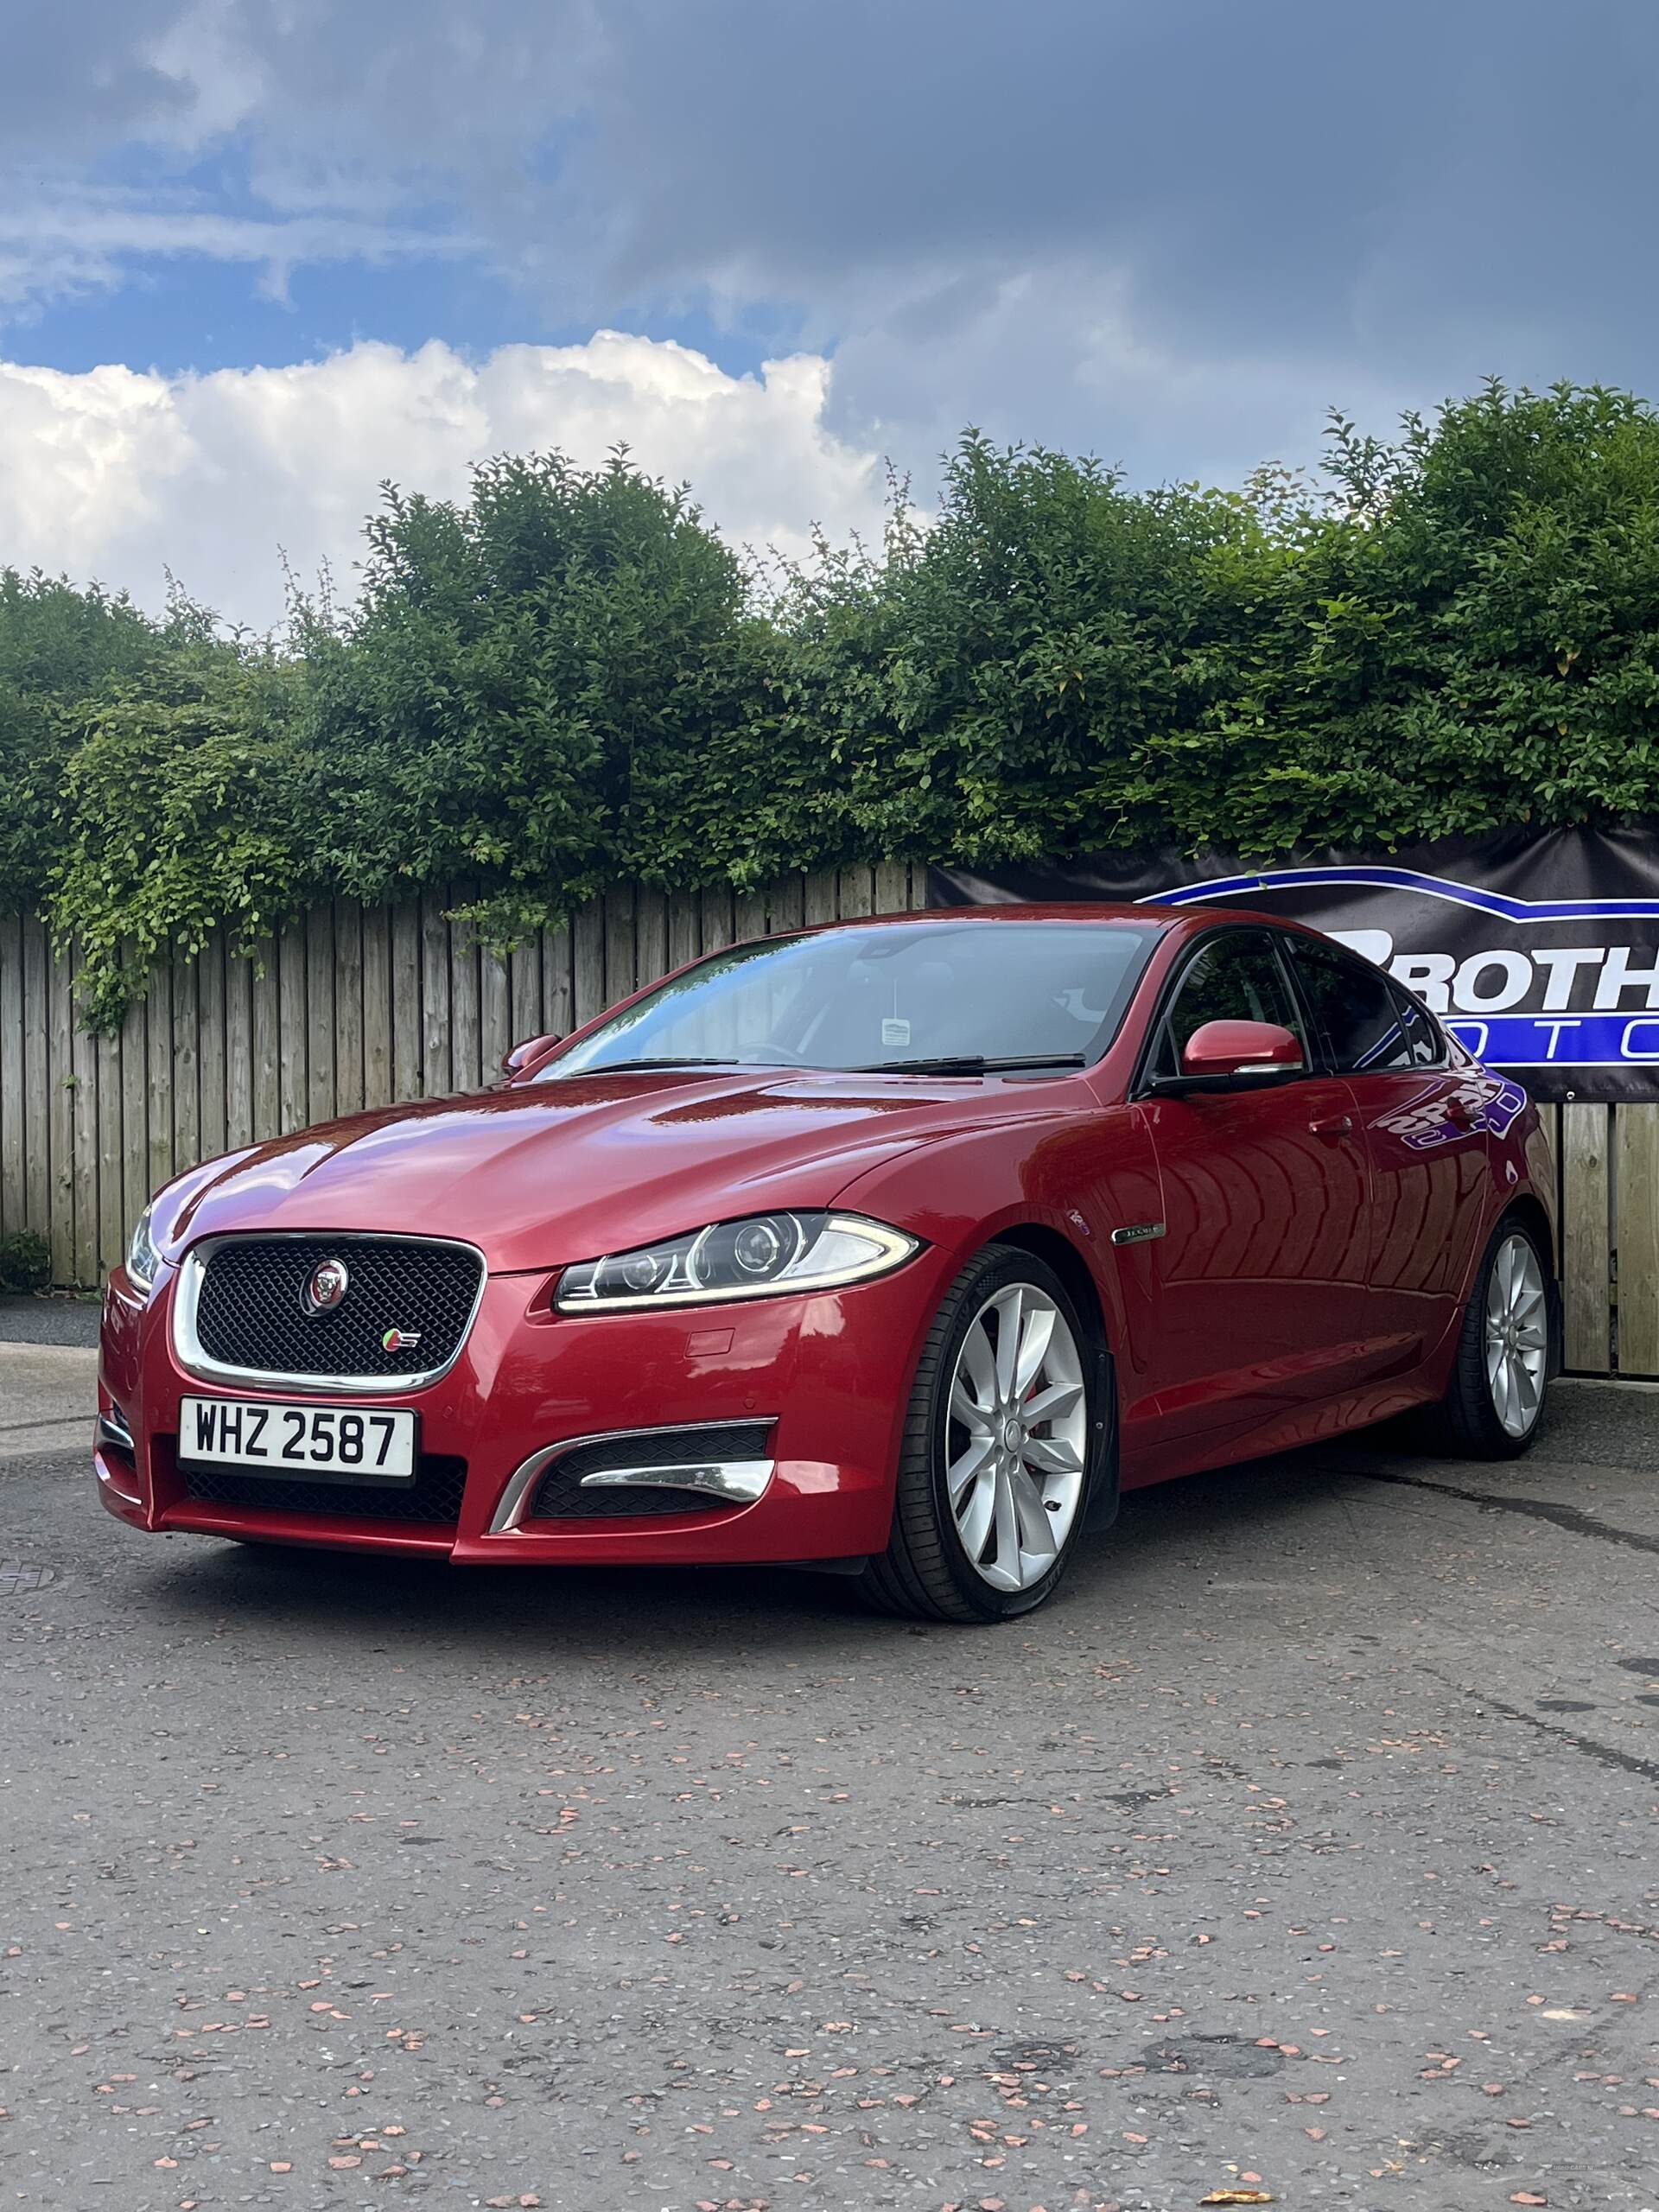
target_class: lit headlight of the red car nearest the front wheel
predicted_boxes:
[553,1214,920,1314]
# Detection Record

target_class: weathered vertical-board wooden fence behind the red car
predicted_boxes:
[0,865,1659,1376]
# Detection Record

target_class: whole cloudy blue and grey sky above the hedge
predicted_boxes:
[0,0,1659,624]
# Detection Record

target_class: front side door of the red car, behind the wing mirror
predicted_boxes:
[1139,927,1374,1446]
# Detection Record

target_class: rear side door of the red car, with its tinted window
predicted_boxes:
[1285,936,1486,1367]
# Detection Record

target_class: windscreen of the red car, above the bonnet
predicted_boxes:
[546,920,1157,1082]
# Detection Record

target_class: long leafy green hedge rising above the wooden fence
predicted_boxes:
[0,385,1659,1027]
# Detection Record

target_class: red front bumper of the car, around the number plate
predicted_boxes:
[93,1249,953,1566]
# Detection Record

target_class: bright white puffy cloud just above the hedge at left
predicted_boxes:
[0,329,885,628]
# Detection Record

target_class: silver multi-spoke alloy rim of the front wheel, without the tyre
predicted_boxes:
[944,1283,1089,1591]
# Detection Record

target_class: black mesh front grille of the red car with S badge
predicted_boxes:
[194,1236,485,1387]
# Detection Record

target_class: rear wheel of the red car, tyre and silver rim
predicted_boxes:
[1438,1214,1551,1460]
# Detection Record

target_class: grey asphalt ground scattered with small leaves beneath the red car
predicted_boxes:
[0,1344,1659,2212]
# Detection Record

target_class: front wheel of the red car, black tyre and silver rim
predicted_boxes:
[858,1245,1113,1621]
